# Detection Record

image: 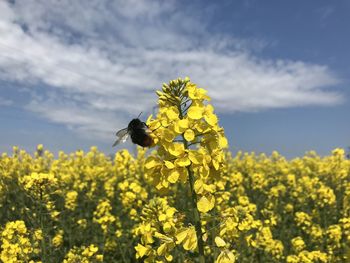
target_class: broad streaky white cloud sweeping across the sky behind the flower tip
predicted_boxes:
[0,0,342,139]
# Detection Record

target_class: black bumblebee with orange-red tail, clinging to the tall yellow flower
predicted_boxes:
[112,113,153,147]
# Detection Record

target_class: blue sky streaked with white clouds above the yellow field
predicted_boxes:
[0,0,350,158]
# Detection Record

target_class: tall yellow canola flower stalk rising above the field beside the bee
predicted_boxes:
[144,78,227,263]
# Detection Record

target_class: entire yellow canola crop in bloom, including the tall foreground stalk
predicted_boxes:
[0,78,350,263]
